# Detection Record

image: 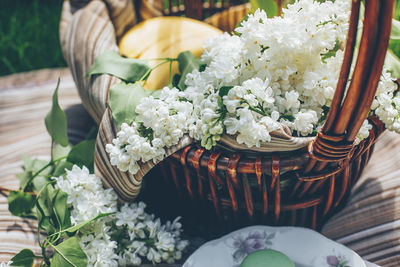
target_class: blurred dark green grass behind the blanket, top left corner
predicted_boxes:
[0,0,400,76]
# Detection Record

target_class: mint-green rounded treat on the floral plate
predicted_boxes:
[240,249,295,267]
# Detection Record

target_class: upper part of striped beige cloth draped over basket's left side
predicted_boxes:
[60,0,136,123]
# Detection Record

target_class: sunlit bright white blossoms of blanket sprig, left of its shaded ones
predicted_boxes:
[54,165,118,267]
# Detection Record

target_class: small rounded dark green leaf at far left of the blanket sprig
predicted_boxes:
[8,191,35,216]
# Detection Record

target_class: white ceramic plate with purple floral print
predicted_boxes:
[183,226,367,267]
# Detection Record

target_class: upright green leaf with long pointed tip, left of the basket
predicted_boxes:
[44,79,68,146]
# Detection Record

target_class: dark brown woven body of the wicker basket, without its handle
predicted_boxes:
[162,118,384,229]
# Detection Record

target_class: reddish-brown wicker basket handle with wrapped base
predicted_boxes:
[305,0,394,173]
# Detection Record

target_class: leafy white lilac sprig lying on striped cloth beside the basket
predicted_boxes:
[5,81,188,267]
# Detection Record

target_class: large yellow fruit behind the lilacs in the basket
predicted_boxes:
[119,17,222,89]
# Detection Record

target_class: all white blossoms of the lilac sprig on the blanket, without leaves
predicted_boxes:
[53,165,188,267]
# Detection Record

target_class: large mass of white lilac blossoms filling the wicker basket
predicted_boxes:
[106,0,400,176]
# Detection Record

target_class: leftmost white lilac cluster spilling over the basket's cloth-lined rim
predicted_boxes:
[106,87,194,177]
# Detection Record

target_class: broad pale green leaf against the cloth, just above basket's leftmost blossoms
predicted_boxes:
[108,82,161,126]
